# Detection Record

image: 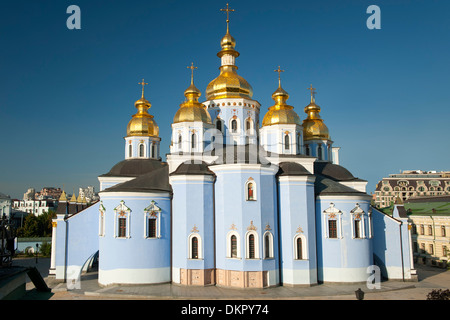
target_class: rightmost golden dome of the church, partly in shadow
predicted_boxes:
[303,93,330,141]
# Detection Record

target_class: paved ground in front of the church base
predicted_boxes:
[13,259,450,300]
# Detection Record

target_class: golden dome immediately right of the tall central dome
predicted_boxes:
[262,77,302,127]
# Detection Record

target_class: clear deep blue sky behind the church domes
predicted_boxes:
[0,0,450,198]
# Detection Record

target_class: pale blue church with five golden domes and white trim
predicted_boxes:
[50,7,415,288]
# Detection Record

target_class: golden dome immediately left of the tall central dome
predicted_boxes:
[173,64,212,124]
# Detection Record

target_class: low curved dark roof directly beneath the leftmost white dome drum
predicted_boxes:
[100,159,167,177]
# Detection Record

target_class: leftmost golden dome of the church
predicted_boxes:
[127,84,159,137]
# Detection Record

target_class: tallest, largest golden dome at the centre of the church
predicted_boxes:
[206,27,253,100]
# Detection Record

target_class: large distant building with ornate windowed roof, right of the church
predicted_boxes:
[374,170,450,208]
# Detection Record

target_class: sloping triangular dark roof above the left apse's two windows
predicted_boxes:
[101,166,172,192]
